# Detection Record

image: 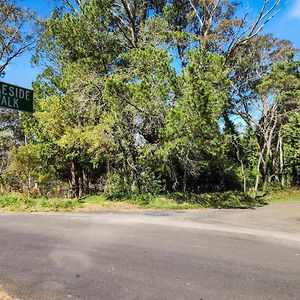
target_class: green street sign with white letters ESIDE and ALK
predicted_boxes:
[0,81,33,112]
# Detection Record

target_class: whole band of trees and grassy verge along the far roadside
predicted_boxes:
[0,0,300,206]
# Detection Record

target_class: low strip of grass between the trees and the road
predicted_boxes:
[0,192,266,212]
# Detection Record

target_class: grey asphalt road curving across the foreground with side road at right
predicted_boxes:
[0,203,300,300]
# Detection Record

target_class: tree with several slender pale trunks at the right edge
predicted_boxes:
[256,53,300,189]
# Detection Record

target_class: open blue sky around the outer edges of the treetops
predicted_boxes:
[2,0,300,88]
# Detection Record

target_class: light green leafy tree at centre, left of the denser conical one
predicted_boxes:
[104,46,177,193]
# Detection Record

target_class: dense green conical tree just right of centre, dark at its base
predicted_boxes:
[163,48,230,192]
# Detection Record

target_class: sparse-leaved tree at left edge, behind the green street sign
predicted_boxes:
[0,0,34,188]
